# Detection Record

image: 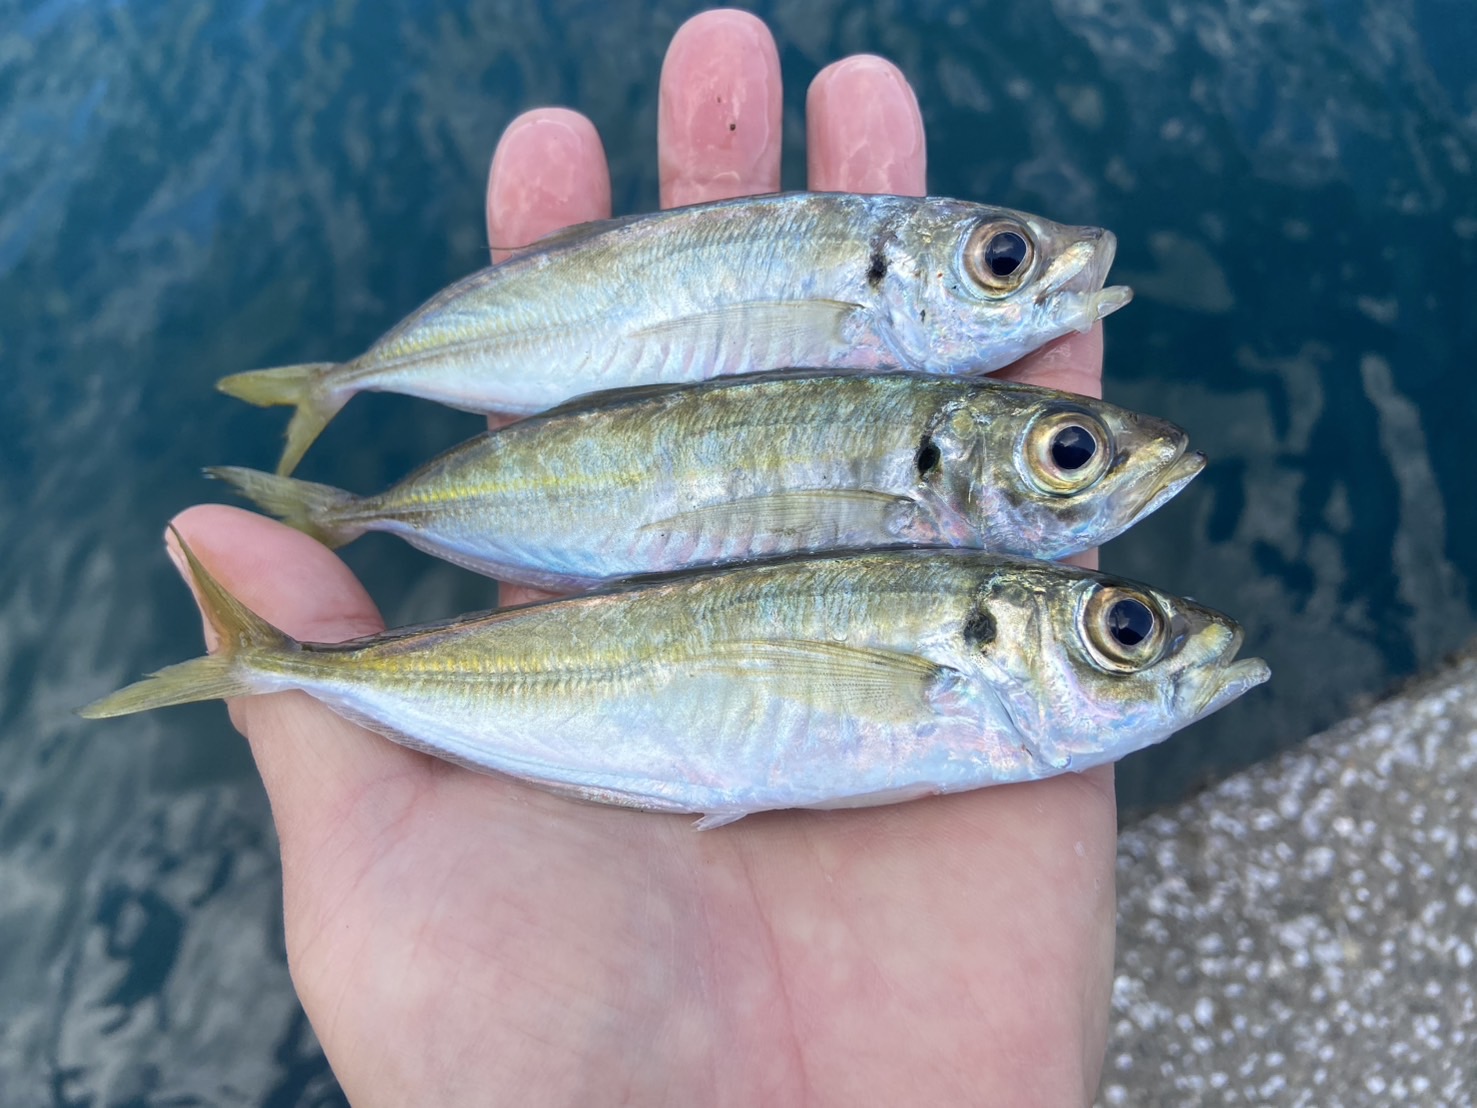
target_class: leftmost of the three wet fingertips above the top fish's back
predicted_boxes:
[487,108,610,261]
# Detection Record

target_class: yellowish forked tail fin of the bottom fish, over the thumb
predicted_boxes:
[77,532,297,719]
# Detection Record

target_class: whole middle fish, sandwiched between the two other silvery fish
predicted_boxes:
[207,371,1205,591]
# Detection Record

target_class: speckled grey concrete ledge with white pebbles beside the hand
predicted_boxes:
[1099,649,1477,1108]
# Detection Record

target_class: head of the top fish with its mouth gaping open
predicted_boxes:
[891,199,1133,372]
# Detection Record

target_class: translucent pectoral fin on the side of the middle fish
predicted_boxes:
[641,489,913,547]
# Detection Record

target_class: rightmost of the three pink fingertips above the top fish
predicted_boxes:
[805,55,928,196]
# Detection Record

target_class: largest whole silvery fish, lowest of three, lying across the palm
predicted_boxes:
[80,535,1270,827]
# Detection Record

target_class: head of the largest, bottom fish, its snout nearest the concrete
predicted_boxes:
[963,563,1270,777]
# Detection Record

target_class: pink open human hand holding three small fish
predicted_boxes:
[174,12,1115,1105]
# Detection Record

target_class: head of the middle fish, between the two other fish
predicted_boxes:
[919,381,1205,558]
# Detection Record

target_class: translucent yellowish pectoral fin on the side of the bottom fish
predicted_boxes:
[699,640,954,722]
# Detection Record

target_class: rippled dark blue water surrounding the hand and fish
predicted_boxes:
[0,0,1477,1105]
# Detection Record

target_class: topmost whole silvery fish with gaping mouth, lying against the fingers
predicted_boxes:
[220,192,1130,474]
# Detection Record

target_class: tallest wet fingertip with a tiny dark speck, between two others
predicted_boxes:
[656,9,781,208]
